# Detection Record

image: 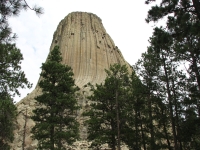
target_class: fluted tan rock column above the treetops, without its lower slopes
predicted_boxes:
[50,12,131,87]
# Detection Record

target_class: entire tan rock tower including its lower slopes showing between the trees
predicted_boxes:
[12,12,131,150]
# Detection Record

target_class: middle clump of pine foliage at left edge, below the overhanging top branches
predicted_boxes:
[0,44,31,96]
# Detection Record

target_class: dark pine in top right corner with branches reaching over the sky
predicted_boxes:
[146,0,200,117]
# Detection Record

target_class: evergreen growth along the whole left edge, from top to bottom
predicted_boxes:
[0,0,42,150]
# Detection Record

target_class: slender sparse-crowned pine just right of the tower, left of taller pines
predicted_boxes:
[132,49,166,150]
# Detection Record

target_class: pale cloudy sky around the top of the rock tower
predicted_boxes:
[9,0,155,102]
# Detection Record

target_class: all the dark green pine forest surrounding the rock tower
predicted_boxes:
[0,0,200,150]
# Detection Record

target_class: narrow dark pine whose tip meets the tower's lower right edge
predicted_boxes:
[124,71,147,150]
